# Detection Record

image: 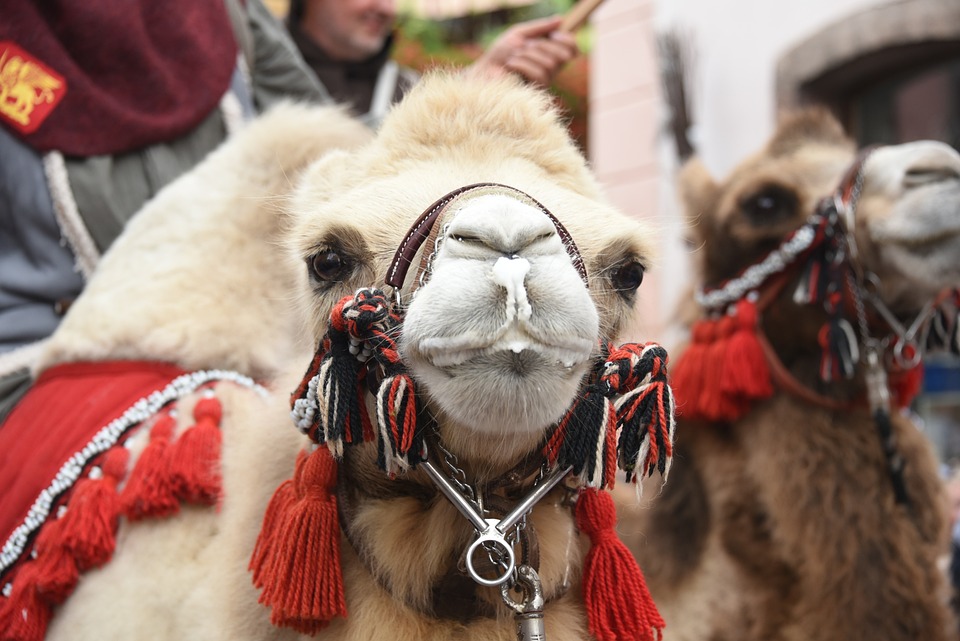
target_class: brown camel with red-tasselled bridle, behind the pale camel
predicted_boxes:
[620,109,960,641]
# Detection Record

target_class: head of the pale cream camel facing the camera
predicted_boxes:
[284,70,651,474]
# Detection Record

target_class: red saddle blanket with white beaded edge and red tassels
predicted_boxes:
[0,361,244,641]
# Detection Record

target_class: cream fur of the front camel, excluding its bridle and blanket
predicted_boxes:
[5,75,668,641]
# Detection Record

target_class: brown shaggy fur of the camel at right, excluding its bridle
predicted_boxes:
[620,110,960,641]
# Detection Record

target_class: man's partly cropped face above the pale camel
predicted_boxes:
[291,0,397,62]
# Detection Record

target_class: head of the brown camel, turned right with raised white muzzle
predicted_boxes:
[678,109,960,418]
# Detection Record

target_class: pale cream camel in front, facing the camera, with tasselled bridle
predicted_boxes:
[0,75,672,641]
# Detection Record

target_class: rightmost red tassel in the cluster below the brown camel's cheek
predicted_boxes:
[723,299,773,400]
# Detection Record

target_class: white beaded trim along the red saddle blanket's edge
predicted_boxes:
[0,369,267,575]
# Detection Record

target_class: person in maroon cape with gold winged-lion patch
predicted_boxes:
[0,0,331,423]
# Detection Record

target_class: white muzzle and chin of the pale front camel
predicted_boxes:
[401,195,599,434]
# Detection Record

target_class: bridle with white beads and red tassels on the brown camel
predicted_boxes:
[671,148,960,503]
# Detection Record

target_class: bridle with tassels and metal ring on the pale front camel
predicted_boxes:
[250,183,674,641]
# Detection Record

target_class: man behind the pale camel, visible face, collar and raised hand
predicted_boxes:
[287,0,578,126]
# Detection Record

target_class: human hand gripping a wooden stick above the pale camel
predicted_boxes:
[469,16,579,87]
